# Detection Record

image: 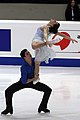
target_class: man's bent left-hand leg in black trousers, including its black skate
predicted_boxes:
[1,81,24,115]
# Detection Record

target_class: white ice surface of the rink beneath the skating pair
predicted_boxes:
[0,66,80,120]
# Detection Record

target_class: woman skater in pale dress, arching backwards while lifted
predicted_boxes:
[32,19,77,83]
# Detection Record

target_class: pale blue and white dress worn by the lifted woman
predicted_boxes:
[33,27,60,63]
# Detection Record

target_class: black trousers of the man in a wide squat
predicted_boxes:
[5,81,52,109]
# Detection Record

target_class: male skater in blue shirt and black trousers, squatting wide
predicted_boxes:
[1,49,52,115]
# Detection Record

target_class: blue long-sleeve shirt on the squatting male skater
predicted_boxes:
[21,59,35,84]
